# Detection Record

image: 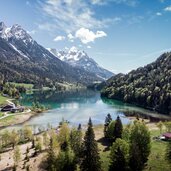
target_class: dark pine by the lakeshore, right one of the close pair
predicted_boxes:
[113,116,123,140]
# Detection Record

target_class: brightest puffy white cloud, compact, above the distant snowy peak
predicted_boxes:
[75,27,107,44]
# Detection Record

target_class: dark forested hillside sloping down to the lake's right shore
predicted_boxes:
[101,52,171,114]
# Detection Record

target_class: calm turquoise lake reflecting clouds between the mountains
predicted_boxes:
[1,89,171,131]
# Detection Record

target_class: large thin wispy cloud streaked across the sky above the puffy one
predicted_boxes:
[39,0,115,33]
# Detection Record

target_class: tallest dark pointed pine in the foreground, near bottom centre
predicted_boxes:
[81,118,101,171]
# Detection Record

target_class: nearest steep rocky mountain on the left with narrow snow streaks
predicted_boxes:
[0,22,102,86]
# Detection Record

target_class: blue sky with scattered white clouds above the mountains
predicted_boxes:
[0,0,171,73]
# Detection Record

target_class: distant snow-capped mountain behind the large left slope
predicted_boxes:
[48,47,114,80]
